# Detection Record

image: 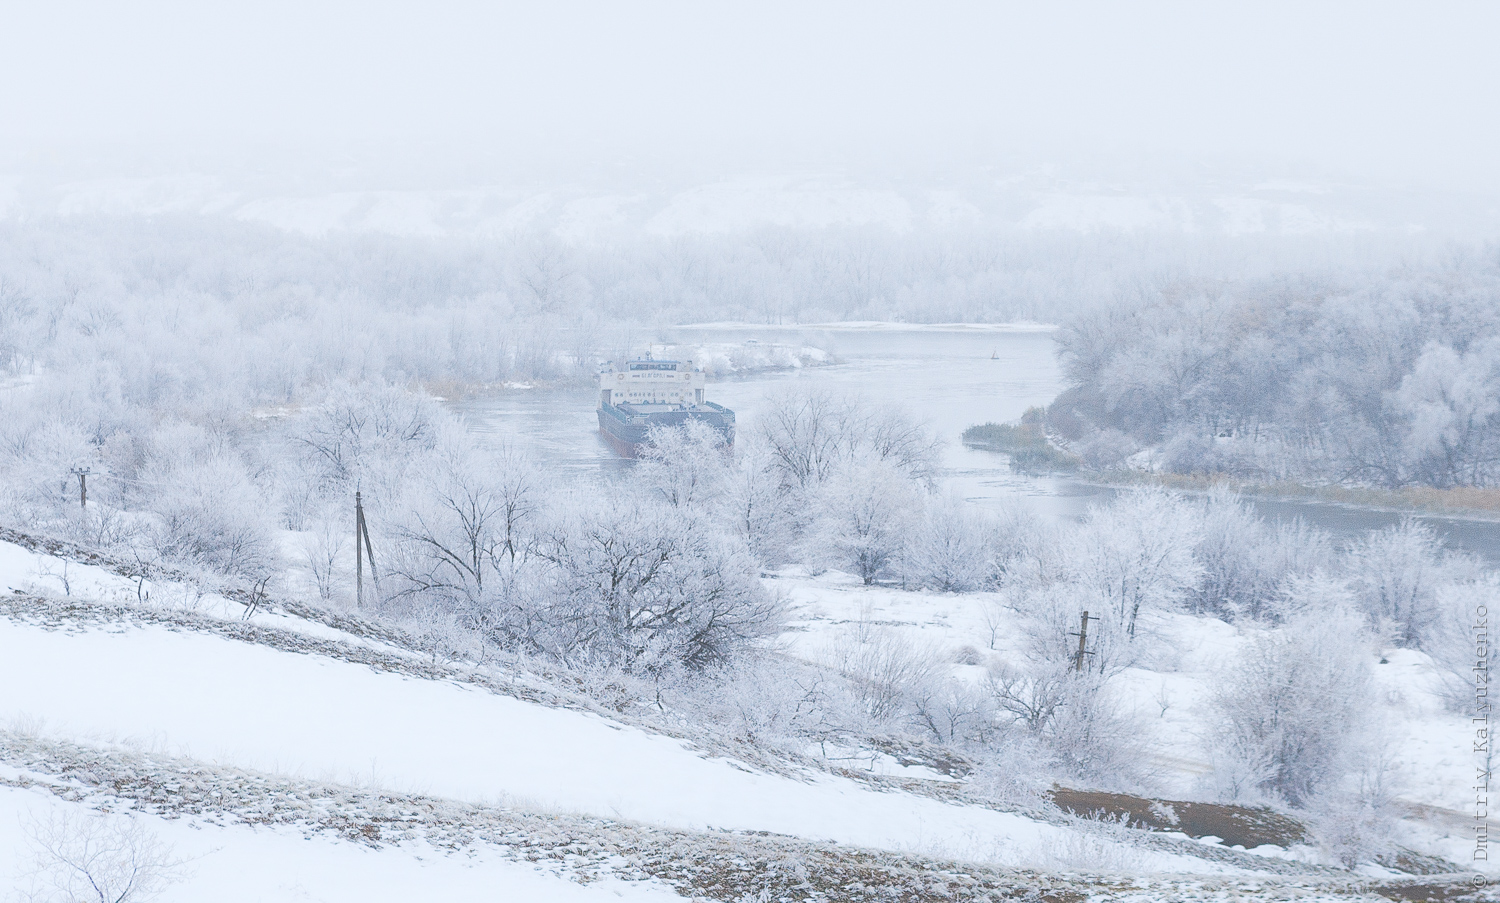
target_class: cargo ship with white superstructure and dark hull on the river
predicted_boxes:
[599,356,735,458]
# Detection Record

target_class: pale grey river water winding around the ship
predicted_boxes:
[450,326,1500,564]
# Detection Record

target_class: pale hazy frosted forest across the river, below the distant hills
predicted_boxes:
[0,216,1412,404]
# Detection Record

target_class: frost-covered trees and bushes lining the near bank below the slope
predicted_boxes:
[8,360,1496,858]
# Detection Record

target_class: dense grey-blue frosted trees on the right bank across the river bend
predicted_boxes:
[1049,249,1500,488]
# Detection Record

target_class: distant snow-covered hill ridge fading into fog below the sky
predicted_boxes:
[0,168,1500,242]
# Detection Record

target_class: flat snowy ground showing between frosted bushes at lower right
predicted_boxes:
[771,570,1494,870]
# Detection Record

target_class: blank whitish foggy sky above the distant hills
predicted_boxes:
[0,2,1500,189]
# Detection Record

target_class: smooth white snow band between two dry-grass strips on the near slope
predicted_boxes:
[0,606,1209,872]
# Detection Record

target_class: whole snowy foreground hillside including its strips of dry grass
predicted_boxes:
[0,531,1482,900]
